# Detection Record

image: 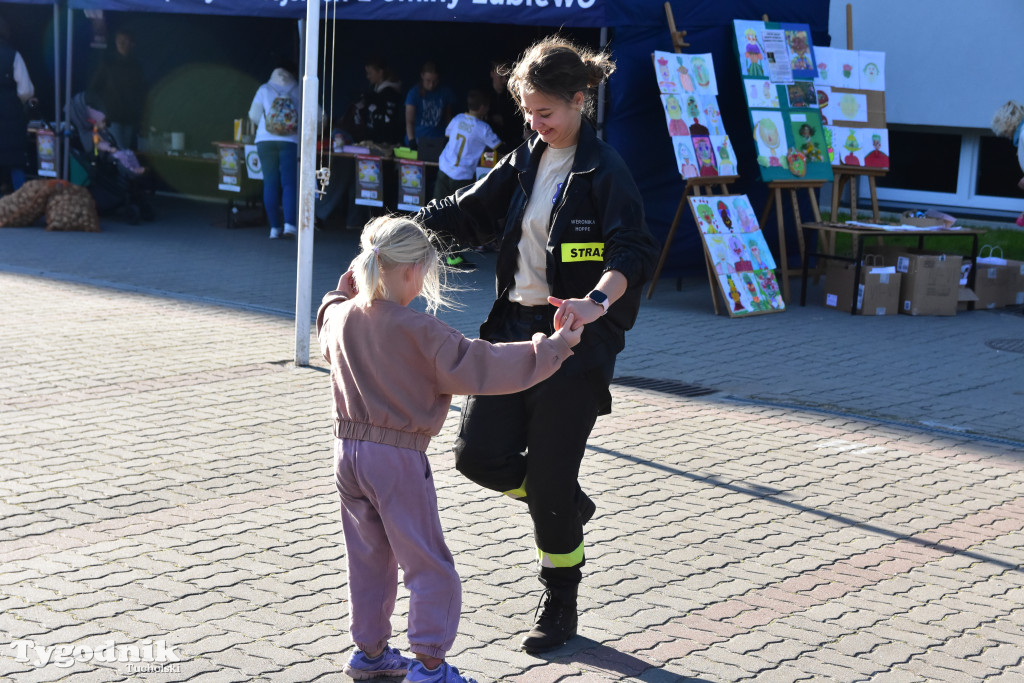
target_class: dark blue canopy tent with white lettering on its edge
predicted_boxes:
[58,0,829,276]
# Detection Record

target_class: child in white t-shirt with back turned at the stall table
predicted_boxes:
[434,90,502,199]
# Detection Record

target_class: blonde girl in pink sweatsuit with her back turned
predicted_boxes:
[316,216,582,683]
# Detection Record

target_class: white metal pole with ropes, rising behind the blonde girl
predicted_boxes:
[295,0,321,366]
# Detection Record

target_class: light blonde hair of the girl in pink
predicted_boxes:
[350,216,452,313]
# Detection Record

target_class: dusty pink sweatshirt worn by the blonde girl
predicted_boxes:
[316,291,572,451]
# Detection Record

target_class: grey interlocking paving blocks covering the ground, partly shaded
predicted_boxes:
[0,194,1024,683]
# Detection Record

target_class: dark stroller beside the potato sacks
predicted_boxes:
[68,92,154,225]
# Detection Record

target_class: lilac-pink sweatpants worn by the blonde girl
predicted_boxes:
[334,439,462,658]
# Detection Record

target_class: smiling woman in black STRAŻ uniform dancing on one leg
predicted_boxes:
[418,36,658,652]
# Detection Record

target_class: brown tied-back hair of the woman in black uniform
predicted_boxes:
[508,35,615,117]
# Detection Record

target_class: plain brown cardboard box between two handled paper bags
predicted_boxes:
[896,253,964,315]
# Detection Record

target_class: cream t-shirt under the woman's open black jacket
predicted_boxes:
[509,144,575,306]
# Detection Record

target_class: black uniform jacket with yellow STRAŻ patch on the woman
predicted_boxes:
[418,119,658,379]
